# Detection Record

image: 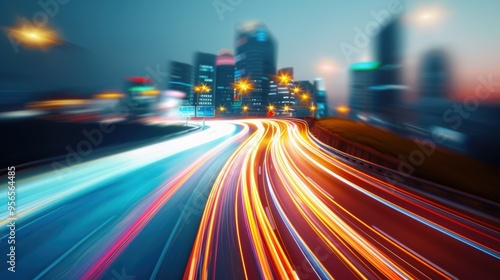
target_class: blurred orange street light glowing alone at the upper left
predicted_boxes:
[6,23,61,48]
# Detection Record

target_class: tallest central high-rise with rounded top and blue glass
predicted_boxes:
[235,22,277,116]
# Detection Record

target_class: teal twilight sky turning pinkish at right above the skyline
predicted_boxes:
[0,0,500,105]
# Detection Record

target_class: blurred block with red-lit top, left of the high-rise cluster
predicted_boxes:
[124,77,160,117]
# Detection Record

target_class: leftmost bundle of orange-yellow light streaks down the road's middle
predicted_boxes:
[185,123,295,279]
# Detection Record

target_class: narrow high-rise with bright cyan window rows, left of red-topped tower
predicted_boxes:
[194,52,216,106]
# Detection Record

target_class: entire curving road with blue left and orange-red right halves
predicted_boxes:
[0,119,500,279]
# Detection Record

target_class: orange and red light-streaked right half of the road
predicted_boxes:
[184,119,500,279]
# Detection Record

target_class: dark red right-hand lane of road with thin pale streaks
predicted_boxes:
[276,119,498,279]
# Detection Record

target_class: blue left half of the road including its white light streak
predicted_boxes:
[0,123,248,279]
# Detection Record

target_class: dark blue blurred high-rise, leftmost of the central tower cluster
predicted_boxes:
[167,61,194,106]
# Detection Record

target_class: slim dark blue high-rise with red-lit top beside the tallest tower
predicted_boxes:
[215,49,235,115]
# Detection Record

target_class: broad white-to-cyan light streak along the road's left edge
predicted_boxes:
[0,123,235,228]
